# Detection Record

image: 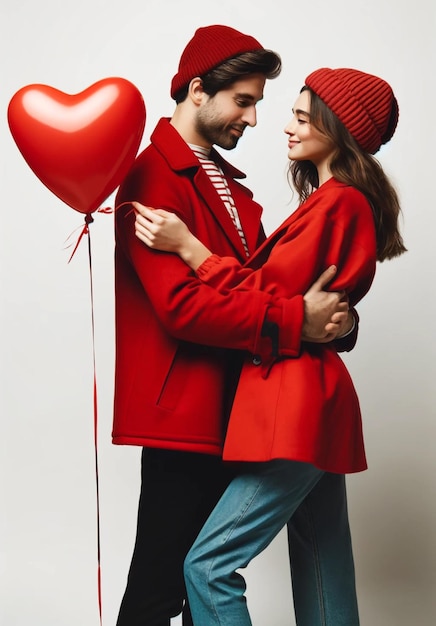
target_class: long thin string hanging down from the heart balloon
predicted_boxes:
[86,221,102,626]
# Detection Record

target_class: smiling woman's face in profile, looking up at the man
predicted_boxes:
[285,91,335,169]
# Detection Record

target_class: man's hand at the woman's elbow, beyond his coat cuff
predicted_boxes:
[301,265,354,343]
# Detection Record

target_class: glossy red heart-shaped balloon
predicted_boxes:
[8,78,145,213]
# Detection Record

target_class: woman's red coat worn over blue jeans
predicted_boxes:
[198,179,376,473]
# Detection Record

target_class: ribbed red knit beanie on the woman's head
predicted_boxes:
[305,68,398,154]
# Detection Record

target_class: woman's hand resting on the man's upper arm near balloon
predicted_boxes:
[132,202,212,270]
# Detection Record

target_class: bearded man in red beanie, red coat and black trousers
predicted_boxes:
[113,25,354,626]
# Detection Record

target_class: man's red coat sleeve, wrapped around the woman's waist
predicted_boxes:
[115,165,303,355]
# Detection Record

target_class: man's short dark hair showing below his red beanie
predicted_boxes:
[174,49,282,104]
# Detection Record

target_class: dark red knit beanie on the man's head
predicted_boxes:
[171,25,263,98]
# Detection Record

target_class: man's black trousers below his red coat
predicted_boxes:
[117,448,235,626]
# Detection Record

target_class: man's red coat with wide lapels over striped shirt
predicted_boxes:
[112,119,303,454]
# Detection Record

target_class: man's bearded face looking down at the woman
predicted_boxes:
[195,74,265,150]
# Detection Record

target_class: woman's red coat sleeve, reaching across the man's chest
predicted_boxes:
[197,189,376,356]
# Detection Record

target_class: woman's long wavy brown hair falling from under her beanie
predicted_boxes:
[289,86,407,261]
